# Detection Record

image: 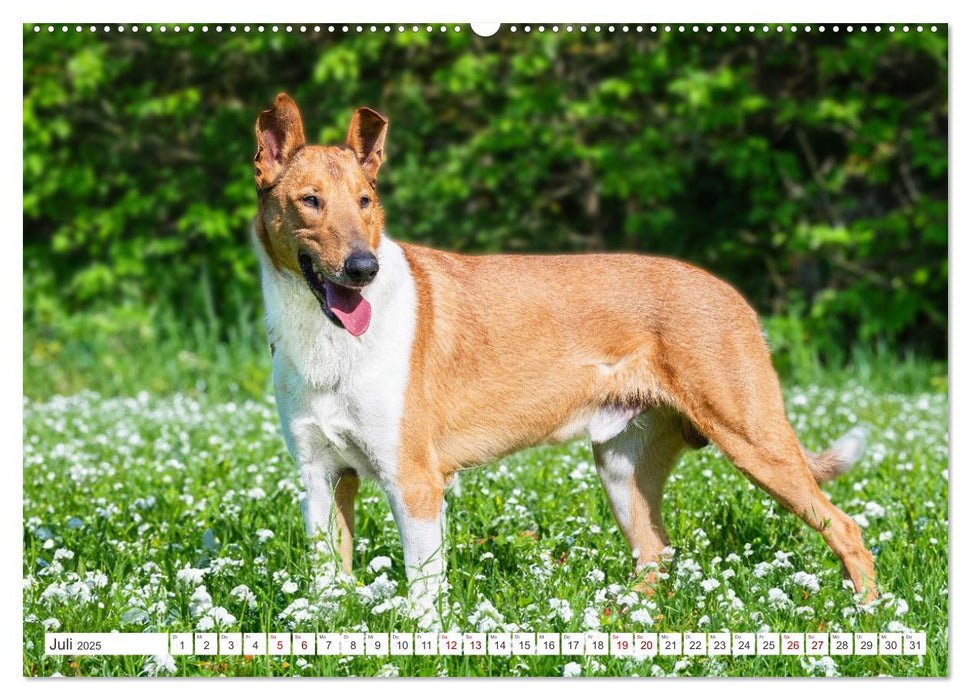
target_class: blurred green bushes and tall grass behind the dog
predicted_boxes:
[23,25,948,394]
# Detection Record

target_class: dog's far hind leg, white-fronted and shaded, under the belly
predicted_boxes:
[593,408,686,593]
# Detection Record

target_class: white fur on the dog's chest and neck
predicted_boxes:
[263,239,416,478]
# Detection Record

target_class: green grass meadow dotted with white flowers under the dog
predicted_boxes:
[23,349,948,676]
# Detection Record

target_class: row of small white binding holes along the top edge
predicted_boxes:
[33,24,938,34]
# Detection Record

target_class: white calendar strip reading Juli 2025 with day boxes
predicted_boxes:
[45,631,927,657]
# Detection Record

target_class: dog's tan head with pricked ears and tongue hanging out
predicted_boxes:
[253,93,388,336]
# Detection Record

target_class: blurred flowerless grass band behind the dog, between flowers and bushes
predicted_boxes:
[23,302,947,401]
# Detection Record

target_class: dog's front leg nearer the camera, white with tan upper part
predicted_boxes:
[385,476,445,612]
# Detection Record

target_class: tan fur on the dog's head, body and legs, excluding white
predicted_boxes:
[257,96,875,599]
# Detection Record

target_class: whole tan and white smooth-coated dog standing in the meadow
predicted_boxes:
[254,94,875,600]
